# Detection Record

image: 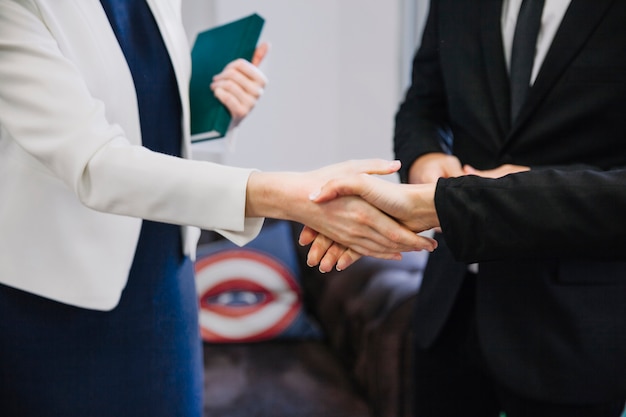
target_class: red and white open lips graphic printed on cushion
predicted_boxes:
[196,249,302,343]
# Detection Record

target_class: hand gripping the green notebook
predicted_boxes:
[211,43,269,126]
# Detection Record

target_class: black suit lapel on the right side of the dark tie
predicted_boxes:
[510,0,615,134]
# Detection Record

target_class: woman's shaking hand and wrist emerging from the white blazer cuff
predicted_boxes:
[246,159,437,268]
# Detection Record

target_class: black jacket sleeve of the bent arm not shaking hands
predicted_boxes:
[394,1,451,182]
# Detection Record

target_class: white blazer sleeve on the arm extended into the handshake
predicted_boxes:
[0,1,260,243]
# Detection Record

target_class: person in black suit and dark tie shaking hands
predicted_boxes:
[302,0,626,417]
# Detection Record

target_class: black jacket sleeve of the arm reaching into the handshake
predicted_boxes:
[435,169,626,262]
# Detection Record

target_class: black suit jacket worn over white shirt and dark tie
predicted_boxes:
[395,0,626,402]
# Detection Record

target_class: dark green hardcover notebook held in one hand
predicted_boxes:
[189,13,265,142]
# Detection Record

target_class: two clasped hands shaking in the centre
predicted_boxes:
[246,159,439,272]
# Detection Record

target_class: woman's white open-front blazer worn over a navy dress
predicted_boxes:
[0,0,263,310]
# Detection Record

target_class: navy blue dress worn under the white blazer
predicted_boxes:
[0,0,202,417]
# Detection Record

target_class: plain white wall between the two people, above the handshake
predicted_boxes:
[179,0,424,170]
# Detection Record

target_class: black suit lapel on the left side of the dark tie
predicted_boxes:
[480,0,510,137]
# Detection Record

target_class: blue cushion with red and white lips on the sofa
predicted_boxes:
[196,221,322,343]
